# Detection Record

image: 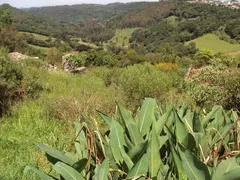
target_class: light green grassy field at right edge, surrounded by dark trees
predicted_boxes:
[186,34,240,53]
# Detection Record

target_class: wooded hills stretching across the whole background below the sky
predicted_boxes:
[2,1,240,46]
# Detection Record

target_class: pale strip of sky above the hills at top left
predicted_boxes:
[0,0,158,8]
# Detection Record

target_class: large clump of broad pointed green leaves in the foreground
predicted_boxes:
[25,98,240,180]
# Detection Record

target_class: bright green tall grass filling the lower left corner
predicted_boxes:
[0,100,73,180]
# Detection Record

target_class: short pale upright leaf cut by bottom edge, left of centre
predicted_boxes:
[94,158,109,180]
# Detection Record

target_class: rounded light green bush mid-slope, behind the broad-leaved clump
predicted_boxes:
[119,63,174,106]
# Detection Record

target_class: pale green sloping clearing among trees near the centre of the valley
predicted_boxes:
[108,28,139,47]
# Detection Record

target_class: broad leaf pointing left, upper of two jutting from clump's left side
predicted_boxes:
[36,143,74,166]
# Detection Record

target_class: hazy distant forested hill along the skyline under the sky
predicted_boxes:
[24,2,151,25]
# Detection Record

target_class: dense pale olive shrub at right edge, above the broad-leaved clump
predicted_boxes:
[186,65,240,110]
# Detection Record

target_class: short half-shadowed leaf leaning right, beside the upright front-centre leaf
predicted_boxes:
[127,140,148,164]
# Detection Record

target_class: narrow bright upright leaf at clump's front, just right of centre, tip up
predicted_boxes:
[148,128,163,178]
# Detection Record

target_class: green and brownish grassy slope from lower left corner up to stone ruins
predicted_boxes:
[0,68,122,180]
